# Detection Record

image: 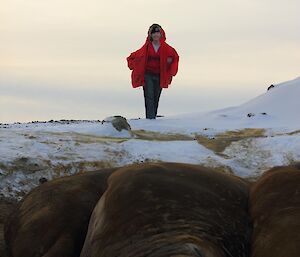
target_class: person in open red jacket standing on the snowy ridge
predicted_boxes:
[127,23,179,119]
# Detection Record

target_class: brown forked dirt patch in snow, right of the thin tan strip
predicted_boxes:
[196,128,265,154]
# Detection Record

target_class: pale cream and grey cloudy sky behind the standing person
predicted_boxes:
[0,0,300,122]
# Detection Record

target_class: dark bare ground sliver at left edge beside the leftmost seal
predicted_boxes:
[0,197,16,257]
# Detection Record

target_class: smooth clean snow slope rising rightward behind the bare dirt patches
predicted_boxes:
[132,77,300,133]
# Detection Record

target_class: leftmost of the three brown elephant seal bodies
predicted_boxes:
[5,169,116,257]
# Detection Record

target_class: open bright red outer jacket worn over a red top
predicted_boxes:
[127,29,179,88]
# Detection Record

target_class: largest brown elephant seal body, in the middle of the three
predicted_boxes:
[80,163,251,257]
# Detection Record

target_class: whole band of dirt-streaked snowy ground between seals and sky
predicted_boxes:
[0,77,300,198]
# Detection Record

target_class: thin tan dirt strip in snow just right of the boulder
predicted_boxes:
[131,129,195,141]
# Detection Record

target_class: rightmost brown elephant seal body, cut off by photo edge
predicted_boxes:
[250,165,300,257]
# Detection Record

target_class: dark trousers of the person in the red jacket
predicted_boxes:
[143,73,162,119]
